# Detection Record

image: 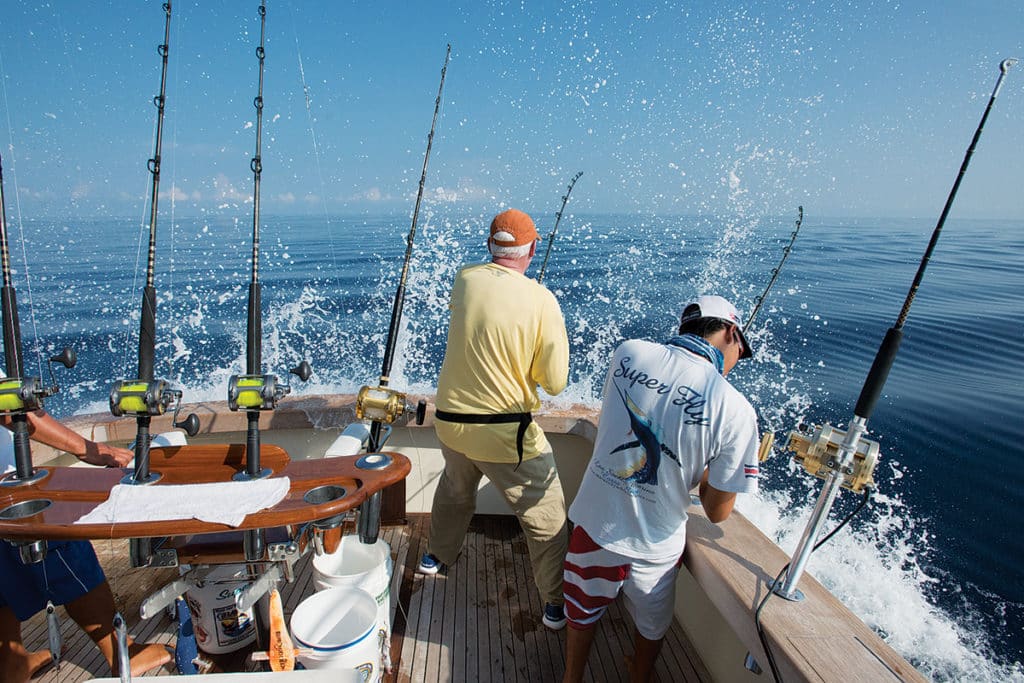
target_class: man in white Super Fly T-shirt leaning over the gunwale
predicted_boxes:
[564,296,758,681]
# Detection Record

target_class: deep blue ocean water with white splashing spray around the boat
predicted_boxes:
[9,208,1024,681]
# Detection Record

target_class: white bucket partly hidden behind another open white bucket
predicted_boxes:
[313,533,391,637]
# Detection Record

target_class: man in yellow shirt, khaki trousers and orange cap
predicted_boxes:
[419,209,568,629]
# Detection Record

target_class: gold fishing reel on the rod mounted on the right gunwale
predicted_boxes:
[785,424,879,494]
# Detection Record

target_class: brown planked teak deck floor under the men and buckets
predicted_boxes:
[23,514,711,683]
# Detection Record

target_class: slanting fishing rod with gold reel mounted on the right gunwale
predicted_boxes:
[758,58,1017,681]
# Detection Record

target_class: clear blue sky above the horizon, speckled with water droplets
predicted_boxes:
[0,0,1024,220]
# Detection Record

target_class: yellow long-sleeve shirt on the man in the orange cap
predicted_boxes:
[434,263,569,463]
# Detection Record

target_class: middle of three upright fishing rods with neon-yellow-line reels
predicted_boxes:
[110,2,199,497]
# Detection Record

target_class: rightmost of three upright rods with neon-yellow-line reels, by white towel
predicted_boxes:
[227,0,312,505]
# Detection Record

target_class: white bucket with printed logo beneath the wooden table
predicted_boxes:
[185,564,256,654]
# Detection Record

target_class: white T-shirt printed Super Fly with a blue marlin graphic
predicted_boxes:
[569,339,759,561]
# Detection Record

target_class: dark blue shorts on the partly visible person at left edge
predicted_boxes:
[0,541,106,622]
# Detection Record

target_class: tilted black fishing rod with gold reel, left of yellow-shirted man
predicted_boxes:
[355,43,452,543]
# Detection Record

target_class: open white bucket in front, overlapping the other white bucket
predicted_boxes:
[291,587,383,681]
